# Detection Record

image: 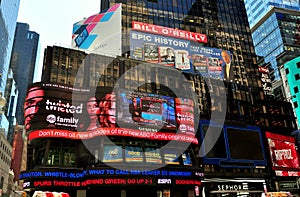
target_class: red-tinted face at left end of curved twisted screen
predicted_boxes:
[24,87,44,130]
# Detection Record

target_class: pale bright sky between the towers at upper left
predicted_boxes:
[17,0,100,82]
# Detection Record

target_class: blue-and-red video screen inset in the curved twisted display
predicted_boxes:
[117,90,177,131]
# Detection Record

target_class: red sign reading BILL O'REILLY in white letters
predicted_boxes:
[132,21,207,43]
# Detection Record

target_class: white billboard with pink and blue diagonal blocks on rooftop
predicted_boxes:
[71,4,122,56]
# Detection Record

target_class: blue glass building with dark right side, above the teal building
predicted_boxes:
[251,8,299,81]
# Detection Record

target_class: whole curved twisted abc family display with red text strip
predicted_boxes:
[24,82,198,144]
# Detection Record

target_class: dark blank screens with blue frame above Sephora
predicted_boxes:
[199,120,267,168]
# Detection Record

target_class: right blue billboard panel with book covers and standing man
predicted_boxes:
[190,44,233,80]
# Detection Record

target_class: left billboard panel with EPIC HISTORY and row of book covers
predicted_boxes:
[130,31,192,72]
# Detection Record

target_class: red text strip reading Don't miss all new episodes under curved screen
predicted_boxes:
[28,128,198,144]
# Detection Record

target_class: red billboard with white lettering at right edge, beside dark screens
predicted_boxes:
[266,132,300,170]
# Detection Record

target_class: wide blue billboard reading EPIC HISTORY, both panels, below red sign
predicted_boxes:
[130,30,234,80]
